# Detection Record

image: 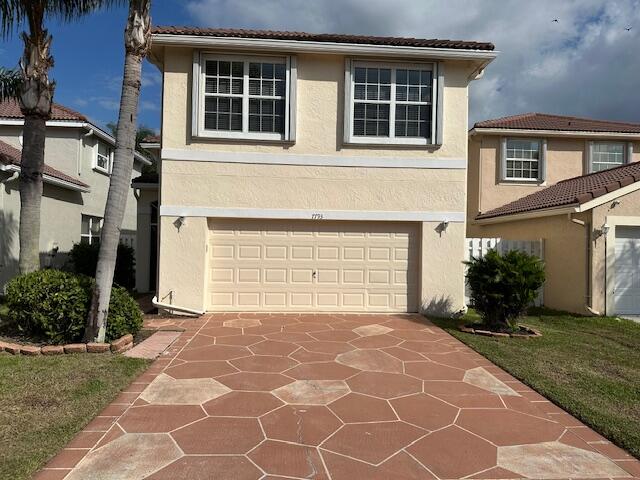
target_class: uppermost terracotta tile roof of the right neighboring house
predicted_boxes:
[473,113,640,134]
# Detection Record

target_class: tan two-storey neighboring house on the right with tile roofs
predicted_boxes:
[467,114,640,315]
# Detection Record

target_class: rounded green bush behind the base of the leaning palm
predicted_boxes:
[6,270,142,343]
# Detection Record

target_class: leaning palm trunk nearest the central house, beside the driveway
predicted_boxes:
[84,0,151,342]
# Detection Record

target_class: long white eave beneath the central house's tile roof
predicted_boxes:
[152,33,499,62]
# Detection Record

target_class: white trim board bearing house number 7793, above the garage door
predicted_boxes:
[160,205,465,223]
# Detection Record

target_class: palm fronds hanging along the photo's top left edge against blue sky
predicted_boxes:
[0,0,128,38]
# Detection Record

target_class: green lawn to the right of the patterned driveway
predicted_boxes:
[434,311,640,458]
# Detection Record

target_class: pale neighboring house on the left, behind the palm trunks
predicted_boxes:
[0,101,151,290]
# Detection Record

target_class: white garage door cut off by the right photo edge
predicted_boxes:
[614,227,640,315]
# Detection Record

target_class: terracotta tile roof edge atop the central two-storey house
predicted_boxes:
[152,25,495,51]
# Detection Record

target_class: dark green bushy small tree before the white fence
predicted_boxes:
[465,250,545,331]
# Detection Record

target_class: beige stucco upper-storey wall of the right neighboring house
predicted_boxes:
[467,134,640,236]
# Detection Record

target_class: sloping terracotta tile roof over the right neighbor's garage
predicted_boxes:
[476,162,640,220]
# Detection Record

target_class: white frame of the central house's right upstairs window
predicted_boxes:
[344,59,444,146]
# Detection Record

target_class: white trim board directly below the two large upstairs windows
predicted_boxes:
[161,148,467,170]
